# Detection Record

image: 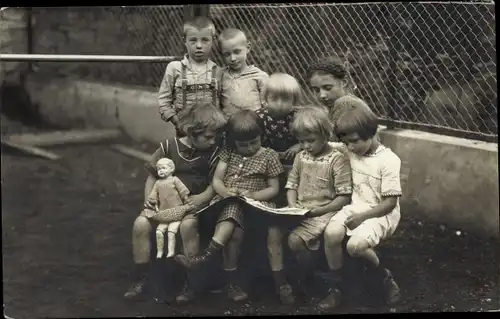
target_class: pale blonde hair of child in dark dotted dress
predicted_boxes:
[264,73,303,106]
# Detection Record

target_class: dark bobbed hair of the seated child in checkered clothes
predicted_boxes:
[226,110,264,149]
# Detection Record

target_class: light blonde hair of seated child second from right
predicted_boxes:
[290,105,333,140]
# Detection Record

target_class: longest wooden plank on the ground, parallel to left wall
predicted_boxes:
[7,130,122,146]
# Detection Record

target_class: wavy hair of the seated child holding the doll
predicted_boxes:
[180,103,227,137]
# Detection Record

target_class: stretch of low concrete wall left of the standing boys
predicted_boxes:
[25,74,175,143]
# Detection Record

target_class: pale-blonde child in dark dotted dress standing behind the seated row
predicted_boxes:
[256,73,302,165]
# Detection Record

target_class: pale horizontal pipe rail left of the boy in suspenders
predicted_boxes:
[0,54,182,62]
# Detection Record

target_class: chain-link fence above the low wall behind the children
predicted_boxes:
[34,1,498,140]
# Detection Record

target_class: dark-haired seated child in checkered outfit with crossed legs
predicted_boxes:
[175,110,283,301]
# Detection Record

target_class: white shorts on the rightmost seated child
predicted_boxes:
[330,205,397,247]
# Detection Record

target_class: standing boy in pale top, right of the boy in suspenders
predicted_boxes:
[219,28,269,116]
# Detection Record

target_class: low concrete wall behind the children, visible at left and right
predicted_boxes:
[26,74,499,237]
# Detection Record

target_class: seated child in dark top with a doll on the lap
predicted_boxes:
[125,103,226,303]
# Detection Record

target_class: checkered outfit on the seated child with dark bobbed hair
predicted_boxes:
[211,148,283,228]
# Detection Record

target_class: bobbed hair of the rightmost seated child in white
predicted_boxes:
[334,95,379,140]
